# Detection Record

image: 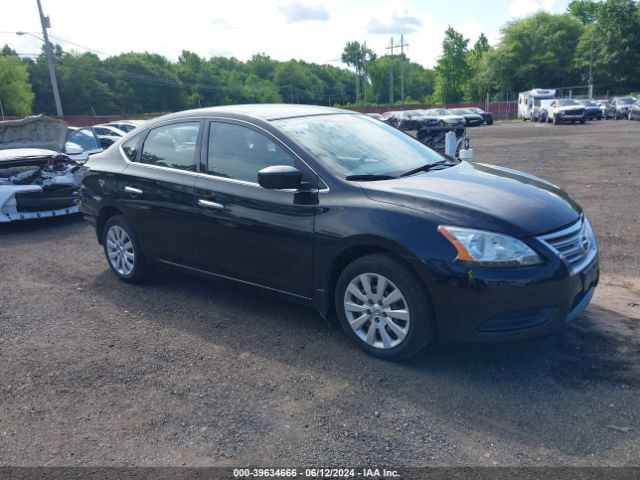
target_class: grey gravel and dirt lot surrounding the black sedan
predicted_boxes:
[0,121,640,466]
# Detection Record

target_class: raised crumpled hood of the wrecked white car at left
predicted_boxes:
[0,115,67,152]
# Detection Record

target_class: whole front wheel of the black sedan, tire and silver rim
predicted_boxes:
[335,254,435,360]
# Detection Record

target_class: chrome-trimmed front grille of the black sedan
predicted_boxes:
[538,218,598,273]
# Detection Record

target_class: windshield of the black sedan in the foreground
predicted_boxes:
[272,114,444,178]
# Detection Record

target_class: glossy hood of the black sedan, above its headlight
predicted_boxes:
[360,162,582,237]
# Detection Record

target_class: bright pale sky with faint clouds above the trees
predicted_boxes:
[0,0,569,67]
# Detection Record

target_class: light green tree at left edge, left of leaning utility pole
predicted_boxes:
[0,56,34,116]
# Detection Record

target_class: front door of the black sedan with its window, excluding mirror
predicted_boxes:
[196,121,318,298]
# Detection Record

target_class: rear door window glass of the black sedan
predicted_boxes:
[140,122,200,171]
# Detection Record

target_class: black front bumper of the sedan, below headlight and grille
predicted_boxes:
[410,255,599,343]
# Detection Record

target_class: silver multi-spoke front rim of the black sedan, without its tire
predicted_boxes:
[344,273,411,350]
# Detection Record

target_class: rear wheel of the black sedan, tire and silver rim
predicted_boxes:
[102,215,150,283]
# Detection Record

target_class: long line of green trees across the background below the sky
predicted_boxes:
[0,0,640,115]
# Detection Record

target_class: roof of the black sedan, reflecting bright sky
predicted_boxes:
[155,103,350,121]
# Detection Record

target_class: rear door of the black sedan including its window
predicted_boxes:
[120,120,203,266]
